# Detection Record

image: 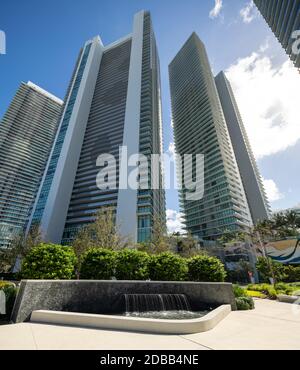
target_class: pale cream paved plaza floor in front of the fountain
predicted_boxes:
[0,300,300,350]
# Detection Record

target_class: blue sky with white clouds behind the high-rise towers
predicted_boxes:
[0,0,300,231]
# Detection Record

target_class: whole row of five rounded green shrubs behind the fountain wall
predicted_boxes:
[20,244,226,282]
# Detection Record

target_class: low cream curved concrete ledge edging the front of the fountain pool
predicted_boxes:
[30,305,231,335]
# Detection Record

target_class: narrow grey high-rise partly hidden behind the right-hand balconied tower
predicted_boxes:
[215,71,270,223]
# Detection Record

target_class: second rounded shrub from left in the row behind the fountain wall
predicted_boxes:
[80,248,116,280]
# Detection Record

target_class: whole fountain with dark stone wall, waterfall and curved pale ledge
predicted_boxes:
[12,280,236,334]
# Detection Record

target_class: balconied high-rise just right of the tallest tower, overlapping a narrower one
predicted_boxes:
[169,33,252,240]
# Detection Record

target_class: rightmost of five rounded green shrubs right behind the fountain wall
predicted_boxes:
[187,255,226,282]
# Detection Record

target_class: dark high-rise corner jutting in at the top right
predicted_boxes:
[254,0,300,70]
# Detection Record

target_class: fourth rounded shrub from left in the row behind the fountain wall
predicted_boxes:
[149,252,188,281]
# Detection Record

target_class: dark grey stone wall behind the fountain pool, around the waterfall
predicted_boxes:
[11,280,236,322]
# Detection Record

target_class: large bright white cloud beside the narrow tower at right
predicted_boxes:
[226,44,300,158]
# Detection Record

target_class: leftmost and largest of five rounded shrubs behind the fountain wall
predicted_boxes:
[21,244,77,280]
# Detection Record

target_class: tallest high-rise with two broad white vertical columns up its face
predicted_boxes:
[30,11,165,244]
